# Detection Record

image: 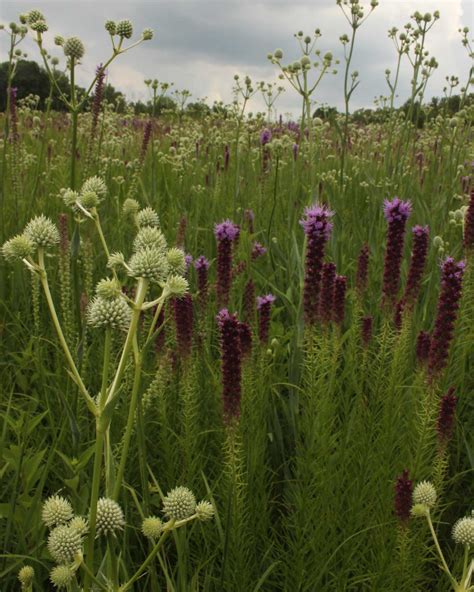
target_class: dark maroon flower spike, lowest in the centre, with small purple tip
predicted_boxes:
[216,308,242,422]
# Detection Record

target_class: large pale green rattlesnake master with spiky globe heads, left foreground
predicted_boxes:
[1,178,214,591]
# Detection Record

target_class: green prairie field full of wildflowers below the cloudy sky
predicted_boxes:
[0,0,474,592]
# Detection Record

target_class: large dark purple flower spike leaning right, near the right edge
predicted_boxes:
[428,257,465,378]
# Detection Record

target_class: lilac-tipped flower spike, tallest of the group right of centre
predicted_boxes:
[382,197,411,305]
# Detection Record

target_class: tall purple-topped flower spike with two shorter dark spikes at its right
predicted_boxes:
[300,204,333,324]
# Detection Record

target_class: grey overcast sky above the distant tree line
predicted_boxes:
[0,0,474,114]
